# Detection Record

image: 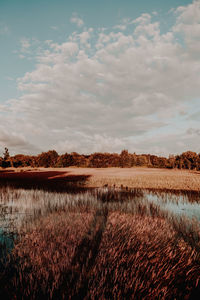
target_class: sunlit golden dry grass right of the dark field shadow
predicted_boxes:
[83,168,200,191]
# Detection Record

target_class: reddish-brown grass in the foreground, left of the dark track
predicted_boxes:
[1,211,92,299]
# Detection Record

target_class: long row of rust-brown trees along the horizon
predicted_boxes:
[0,148,200,170]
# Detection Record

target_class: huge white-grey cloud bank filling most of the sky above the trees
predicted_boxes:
[1,2,200,155]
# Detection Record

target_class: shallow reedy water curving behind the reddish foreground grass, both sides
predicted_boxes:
[0,188,200,260]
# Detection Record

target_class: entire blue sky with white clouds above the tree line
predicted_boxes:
[0,0,200,156]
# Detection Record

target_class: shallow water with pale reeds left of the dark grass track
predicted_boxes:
[0,188,98,235]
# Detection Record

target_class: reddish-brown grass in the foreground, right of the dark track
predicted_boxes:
[88,213,200,299]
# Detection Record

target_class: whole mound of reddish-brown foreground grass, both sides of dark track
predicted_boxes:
[1,206,200,299]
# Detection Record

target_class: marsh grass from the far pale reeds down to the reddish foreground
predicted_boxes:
[0,186,200,299]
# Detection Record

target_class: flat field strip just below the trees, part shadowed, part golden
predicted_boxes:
[0,167,200,191]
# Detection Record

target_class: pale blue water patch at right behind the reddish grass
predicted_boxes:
[145,192,200,221]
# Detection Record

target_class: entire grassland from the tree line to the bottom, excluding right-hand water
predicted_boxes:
[0,168,200,299]
